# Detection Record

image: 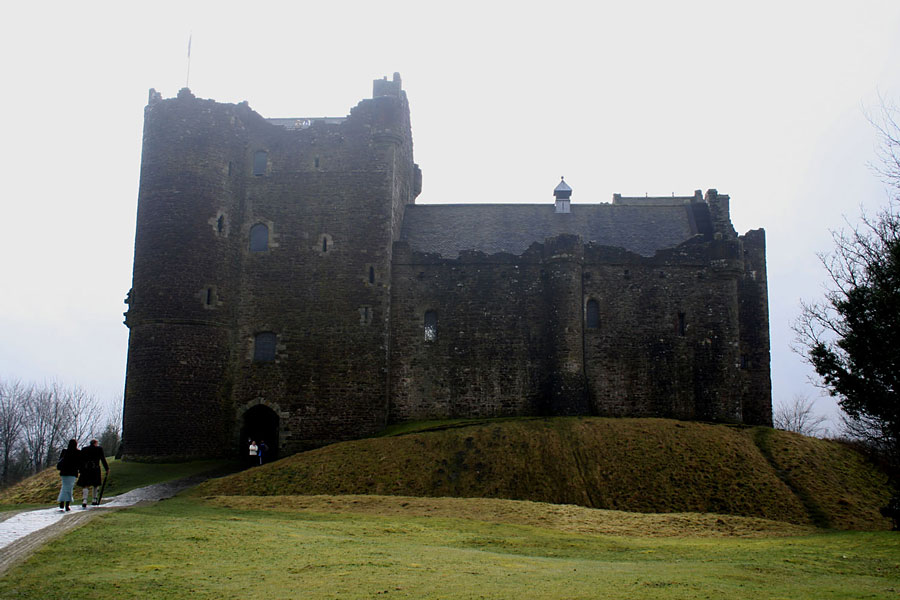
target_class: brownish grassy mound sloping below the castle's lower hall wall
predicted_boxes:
[193,418,890,529]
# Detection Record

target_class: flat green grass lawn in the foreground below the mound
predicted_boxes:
[0,497,900,600]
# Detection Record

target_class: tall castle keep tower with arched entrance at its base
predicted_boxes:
[123,74,421,457]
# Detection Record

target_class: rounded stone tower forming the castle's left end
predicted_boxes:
[123,90,244,456]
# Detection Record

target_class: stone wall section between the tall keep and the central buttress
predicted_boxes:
[390,243,547,421]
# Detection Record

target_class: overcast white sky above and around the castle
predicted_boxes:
[0,0,900,424]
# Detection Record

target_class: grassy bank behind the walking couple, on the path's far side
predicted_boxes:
[0,459,235,505]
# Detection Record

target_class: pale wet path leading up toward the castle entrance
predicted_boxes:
[0,475,207,576]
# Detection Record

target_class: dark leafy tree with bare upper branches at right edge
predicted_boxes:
[795,101,900,467]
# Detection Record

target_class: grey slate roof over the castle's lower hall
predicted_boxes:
[400,203,711,258]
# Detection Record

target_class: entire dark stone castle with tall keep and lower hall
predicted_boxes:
[124,74,772,458]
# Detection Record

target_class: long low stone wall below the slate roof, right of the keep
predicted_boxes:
[390,236,744,422]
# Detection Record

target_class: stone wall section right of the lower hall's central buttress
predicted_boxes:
[584,237,742,422]
